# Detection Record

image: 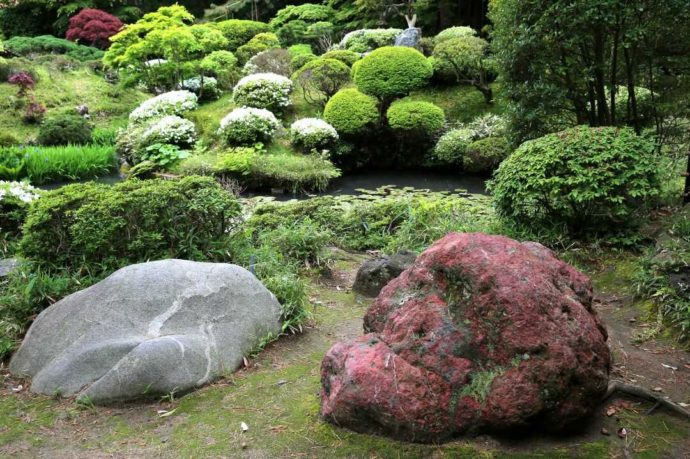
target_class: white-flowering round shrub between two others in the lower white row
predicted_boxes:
[218,107,280,145]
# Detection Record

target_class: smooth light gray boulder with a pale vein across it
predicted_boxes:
[10,260,281,403]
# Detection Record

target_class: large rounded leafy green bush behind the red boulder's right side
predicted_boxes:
[489,127,659,236]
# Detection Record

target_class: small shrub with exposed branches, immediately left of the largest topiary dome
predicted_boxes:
[293,58,350,106]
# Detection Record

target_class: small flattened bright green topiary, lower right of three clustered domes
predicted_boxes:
[386,99,446,137]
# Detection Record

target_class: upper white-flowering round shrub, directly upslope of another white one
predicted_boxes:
[233,73,292,112]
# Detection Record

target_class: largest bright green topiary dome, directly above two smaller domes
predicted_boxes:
[353,46,433,101]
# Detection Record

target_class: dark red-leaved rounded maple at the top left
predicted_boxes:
[66,8,122,49]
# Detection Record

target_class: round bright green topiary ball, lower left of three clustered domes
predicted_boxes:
[323,89,379,135]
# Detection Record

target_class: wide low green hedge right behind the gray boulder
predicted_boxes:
[20,177,240,271]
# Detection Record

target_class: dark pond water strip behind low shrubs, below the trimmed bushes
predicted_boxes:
[40,170,486,200]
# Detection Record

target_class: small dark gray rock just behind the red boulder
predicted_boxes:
[352,250,417,296]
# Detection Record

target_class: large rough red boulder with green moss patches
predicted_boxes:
[321,233,610,441]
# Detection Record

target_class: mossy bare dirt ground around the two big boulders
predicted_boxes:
[0,252,690,458]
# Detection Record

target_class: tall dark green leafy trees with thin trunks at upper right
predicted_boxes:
[490,0,690,144]
